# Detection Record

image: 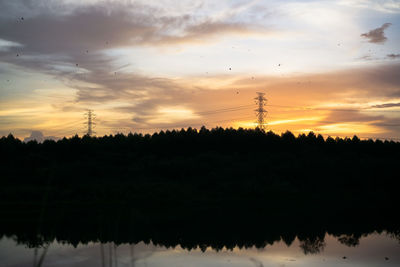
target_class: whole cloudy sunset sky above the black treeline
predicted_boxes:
[0,0,400,140]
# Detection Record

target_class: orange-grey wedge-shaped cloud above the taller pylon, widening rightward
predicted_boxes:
[233,62,400,99]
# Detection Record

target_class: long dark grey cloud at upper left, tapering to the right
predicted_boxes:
[0,1,261,55]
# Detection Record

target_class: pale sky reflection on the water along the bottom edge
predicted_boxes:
[0,234,400,267]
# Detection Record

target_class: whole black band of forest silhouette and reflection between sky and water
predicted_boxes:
[0,127,400,248]
